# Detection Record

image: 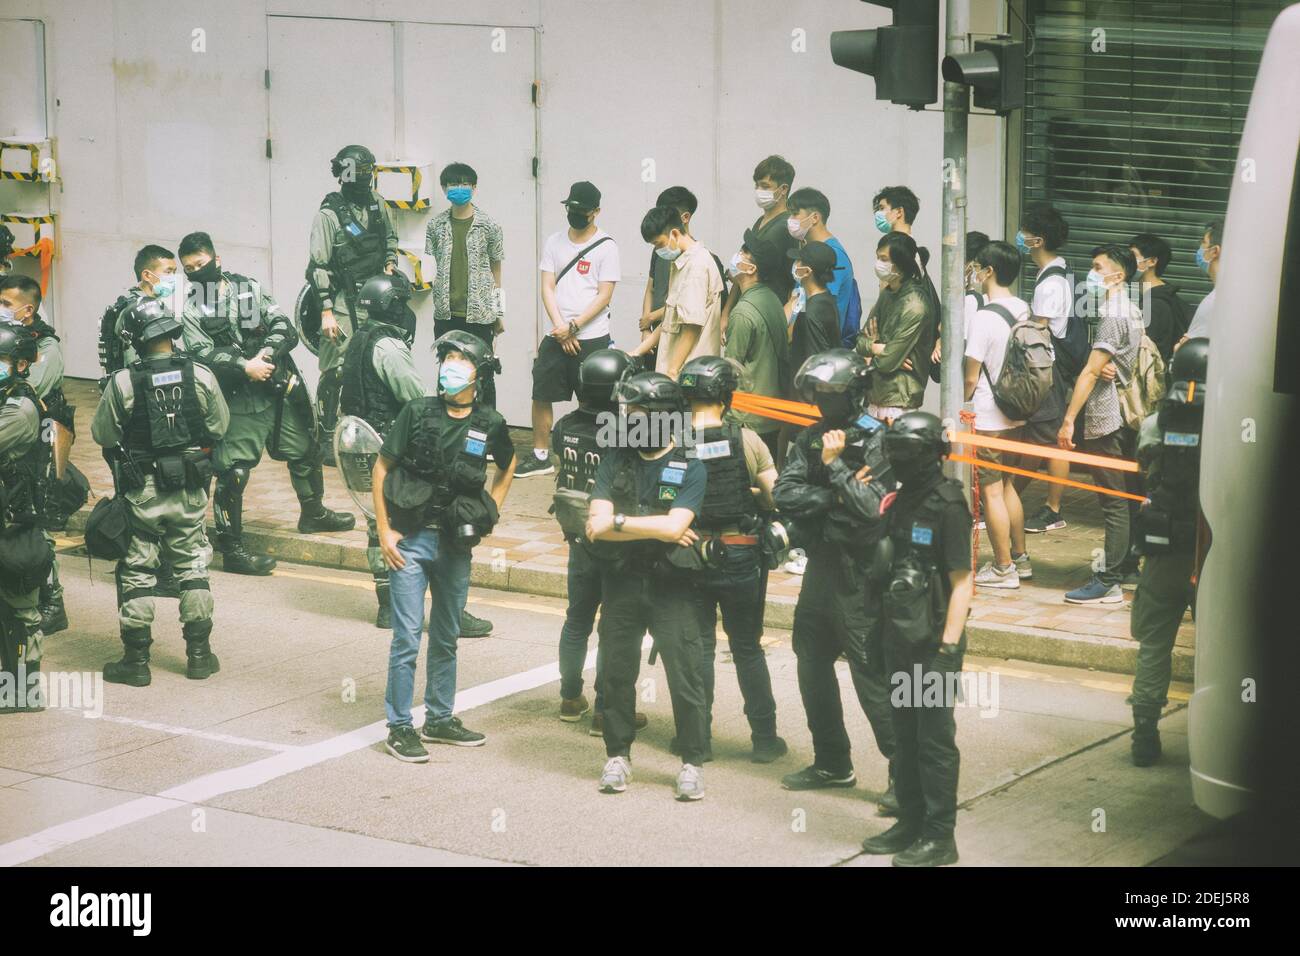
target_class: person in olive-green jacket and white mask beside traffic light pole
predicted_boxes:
[857,230,937,423]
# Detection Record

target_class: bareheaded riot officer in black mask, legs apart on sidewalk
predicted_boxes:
[178,233,356,575]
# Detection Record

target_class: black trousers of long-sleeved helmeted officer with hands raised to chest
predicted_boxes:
[793,545,894,774]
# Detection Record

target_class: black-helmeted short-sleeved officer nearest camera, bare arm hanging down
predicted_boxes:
[862,411,975,866]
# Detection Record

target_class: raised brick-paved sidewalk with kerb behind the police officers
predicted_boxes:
[65,378,1195,680]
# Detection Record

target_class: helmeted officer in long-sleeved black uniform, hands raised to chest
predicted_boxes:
[774,349,894,810]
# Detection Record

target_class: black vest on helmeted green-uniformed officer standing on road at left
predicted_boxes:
[122,355,212,458]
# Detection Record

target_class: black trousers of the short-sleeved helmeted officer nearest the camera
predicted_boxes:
[885,639,965,840]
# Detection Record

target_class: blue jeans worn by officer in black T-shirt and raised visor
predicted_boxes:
[384,528,469,727]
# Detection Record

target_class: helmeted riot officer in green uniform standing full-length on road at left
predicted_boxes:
[91,299,230,687]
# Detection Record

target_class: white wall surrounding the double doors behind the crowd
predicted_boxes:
[0,0,1004,421]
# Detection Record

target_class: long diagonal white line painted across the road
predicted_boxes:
[0,637,613,866]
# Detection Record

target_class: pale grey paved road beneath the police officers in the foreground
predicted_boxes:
[0,555,1209,866]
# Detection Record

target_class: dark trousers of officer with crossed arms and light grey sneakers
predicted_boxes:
[597,562,706,766]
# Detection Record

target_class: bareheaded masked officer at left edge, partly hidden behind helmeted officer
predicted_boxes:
[0,276,77,637]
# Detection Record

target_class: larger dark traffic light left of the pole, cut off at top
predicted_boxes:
[831,0,939,109]
